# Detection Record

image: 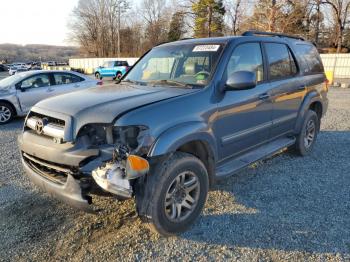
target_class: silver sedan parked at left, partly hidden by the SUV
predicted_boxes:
[0,70,102,125]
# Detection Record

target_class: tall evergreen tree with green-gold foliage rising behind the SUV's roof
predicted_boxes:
[192,0,225,37]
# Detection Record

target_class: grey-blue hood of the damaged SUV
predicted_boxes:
[33,84,198,135]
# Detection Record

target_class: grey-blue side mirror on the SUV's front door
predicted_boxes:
[225,71,256,91]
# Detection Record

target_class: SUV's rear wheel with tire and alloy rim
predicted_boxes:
[294,110,320,156]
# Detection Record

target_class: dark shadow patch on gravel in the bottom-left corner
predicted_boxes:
[0,190,70,254]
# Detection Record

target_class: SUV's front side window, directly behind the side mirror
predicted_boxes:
[227,43,264,82]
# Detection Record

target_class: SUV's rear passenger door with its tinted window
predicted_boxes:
[264,43,306,138]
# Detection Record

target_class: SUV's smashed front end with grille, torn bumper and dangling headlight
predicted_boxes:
[18,111,153,211]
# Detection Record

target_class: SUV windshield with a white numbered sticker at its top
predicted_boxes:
[124,44,223,86]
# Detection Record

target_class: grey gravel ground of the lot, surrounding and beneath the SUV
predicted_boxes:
[0,90,350,261]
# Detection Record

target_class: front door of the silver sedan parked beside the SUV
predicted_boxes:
[16,73,55,112]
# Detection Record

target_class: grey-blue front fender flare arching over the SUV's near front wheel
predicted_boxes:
[148,121,218,161]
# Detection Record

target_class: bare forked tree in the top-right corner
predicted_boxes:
[322,0,350,53]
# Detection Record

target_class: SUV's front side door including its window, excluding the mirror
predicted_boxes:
[213,42,272,161]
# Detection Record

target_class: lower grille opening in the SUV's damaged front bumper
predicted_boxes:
[23,153,74,185]
